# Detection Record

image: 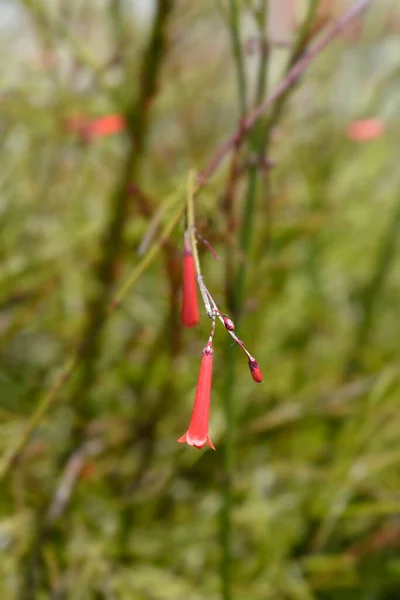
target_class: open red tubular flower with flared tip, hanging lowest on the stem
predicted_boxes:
[178,341,215,450]
